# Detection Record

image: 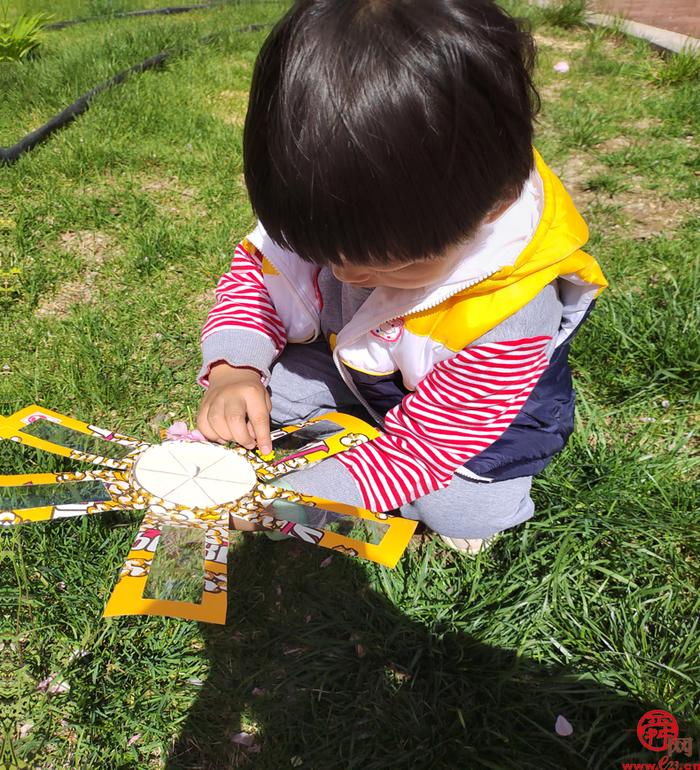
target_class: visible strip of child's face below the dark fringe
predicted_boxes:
[333,247,461,289]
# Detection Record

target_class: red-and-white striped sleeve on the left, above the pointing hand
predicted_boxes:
[202,241,287,356]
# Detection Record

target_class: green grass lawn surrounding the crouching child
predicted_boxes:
[0,0,700,770]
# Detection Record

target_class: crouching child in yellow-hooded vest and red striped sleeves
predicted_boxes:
[197,0,606,553]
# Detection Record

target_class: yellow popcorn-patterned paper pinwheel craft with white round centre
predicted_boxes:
[0,406,416,623]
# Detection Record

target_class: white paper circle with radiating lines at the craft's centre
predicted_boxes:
[131,441,257,508]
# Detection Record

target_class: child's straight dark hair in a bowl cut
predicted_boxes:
[244,0,539,265]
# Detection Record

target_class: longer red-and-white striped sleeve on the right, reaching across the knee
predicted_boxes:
[336,336,551,511]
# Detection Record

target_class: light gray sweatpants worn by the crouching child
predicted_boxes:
[268,342,535,539]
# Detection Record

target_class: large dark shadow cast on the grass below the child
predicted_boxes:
[166,536,658,770]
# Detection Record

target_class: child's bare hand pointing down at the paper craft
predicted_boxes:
[197,363,272,455]
